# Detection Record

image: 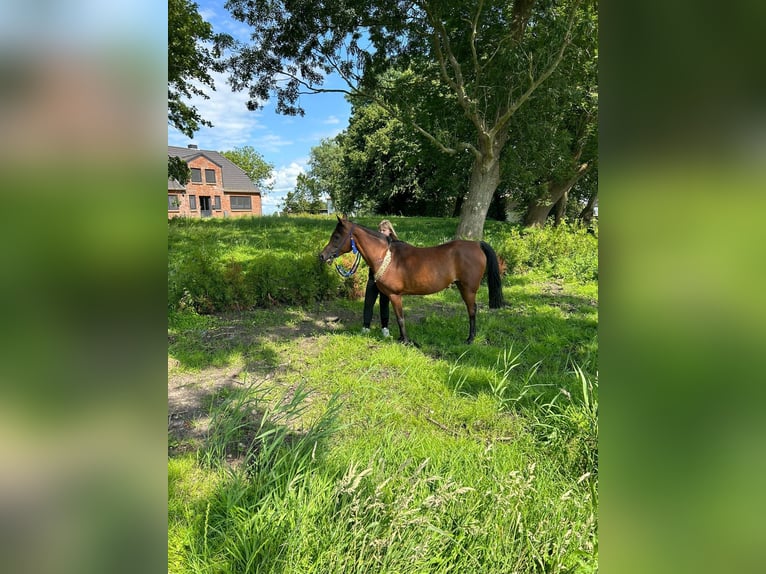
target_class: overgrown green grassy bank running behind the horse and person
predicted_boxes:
[168,216,598,313]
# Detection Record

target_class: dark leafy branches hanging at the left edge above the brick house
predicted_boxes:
[168,0,232,184]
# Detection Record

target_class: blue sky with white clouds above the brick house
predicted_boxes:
[168,0,351,215]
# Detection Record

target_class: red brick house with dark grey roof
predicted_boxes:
[168,145,262,219]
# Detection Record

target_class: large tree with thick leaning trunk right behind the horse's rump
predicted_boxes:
[226,0,595,239]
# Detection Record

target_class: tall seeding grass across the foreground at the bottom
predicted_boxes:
[168,366,597,574]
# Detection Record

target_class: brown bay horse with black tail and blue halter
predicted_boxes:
[319,217,503,343]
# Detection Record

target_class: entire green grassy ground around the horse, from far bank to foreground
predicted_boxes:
[168,217,598,573]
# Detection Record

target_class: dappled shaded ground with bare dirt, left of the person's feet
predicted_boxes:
[168,304,354,456]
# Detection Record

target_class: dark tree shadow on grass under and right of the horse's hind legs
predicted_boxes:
[405,278,598,397]
